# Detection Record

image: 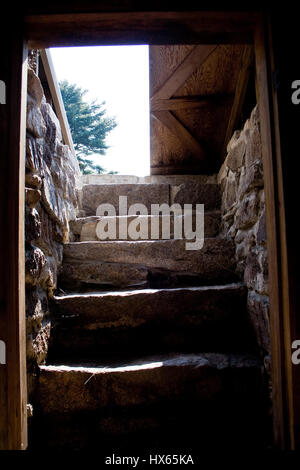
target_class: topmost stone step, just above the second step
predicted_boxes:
[82,182,221,216]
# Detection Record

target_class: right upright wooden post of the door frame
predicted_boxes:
[255,13,294,450]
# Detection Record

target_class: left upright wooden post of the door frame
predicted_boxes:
[0,31,27,450]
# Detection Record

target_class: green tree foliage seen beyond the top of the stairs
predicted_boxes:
[59,80,117,174]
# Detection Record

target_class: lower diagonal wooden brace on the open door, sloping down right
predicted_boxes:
[152,111,205,160]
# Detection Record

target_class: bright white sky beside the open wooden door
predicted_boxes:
[51,46,150,176]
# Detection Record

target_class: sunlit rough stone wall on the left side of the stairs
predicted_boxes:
[25,68,80,400]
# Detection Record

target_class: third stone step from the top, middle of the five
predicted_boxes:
[60,238,237,289]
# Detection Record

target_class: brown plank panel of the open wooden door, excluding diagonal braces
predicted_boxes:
[149,45,244,173]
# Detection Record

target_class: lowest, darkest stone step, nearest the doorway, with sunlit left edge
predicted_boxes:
[31,353,270,448]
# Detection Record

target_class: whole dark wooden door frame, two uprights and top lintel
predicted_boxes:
[0,6,294,449]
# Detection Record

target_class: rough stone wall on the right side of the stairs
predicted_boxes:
[218,106,270,370]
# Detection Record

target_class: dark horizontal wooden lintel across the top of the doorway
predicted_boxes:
[25,11,257,49]
